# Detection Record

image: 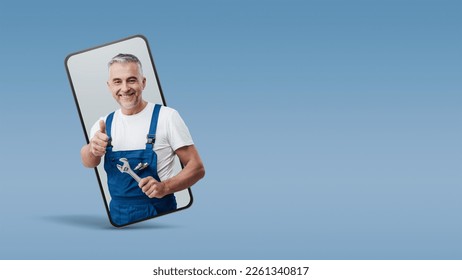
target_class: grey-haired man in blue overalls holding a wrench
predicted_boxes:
[81,54,205,225]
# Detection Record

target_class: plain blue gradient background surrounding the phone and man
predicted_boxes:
[0,0,462,259]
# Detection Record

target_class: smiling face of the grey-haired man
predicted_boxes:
[107,62,146,115]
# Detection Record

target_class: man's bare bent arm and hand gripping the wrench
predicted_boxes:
[139,145,205,198]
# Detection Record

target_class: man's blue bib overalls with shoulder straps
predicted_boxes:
[104,104,176,225]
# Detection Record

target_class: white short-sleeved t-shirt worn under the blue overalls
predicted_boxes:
[90,103,194,181]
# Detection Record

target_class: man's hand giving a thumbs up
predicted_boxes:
[80,120,109,168]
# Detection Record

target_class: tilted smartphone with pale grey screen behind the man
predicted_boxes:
[65,35,192,227]
